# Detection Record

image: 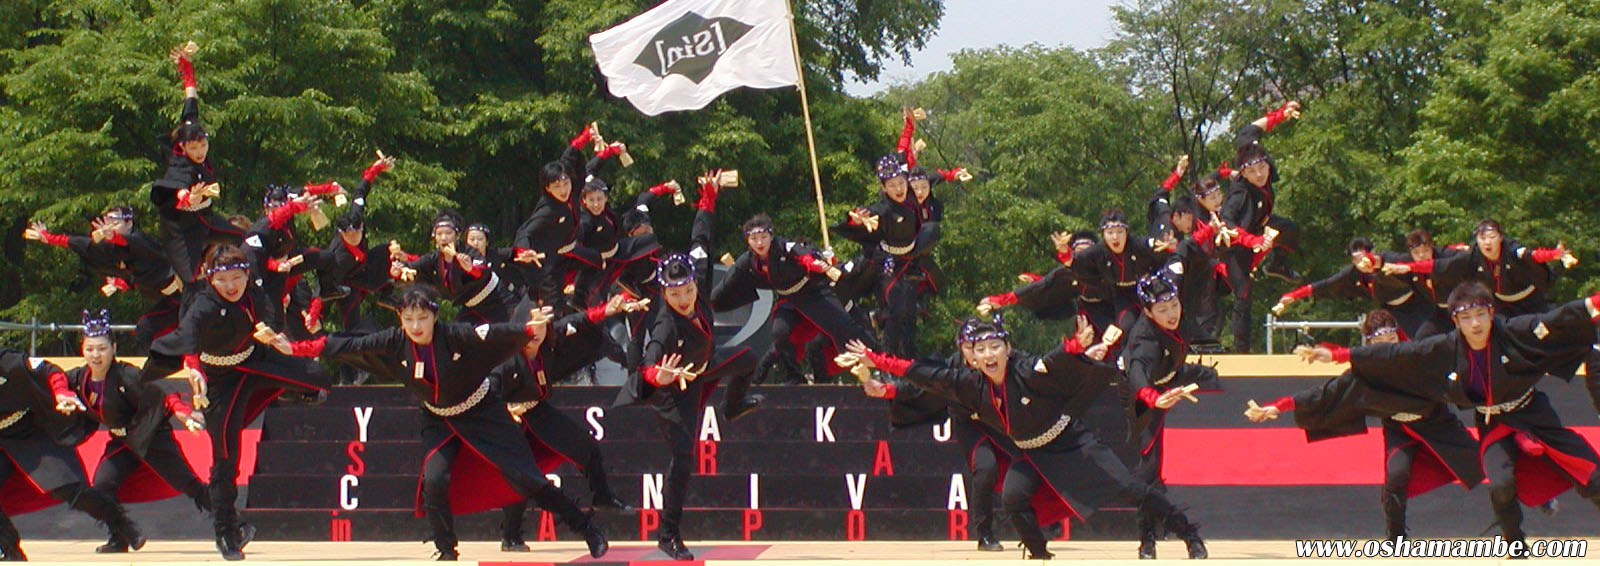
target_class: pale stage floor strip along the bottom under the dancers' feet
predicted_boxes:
[15,539,1600,566]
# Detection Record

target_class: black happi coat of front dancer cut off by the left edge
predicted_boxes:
[0,349,88,515]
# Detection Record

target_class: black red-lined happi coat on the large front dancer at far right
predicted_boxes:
[1350,299,1600,505]
